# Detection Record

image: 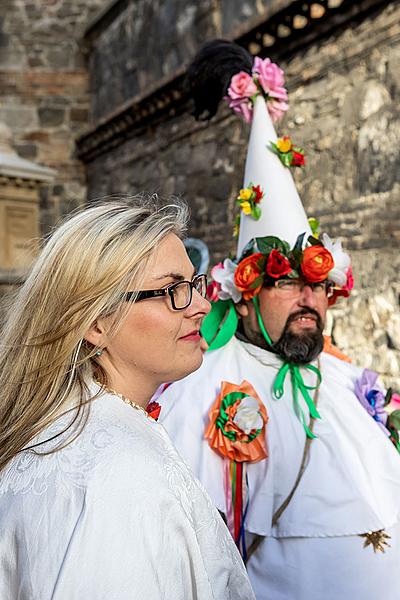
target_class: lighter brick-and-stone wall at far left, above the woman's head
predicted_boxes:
[0,0,105,233]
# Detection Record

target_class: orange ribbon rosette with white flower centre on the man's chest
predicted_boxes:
[204,381,268,463]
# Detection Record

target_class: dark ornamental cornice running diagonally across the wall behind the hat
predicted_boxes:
[77,0,391,162]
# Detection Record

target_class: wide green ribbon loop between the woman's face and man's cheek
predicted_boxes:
[200,300,238,350]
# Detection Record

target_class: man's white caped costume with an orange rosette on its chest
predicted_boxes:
[159,338,400,600]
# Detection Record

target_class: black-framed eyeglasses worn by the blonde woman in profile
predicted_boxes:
[124,274,207,310]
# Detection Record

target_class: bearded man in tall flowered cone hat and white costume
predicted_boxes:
[160,45,400,600]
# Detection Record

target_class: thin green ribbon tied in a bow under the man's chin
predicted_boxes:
[253,296,322,439]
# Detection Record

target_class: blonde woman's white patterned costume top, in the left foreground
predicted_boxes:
[0,384,254,600]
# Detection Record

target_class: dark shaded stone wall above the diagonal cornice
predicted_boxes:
[88,0,268,121]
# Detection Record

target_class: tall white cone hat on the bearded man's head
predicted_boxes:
[236,96,311,258]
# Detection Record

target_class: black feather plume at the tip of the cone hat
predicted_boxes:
[187,40,253,120]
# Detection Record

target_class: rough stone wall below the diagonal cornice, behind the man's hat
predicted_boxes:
[87,2,400,385]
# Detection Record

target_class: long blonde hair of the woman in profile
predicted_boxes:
[0,196,188,470]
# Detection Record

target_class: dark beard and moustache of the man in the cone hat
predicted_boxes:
[268,308,324,364]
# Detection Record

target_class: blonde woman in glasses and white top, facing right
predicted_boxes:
[0,200,253,600]
